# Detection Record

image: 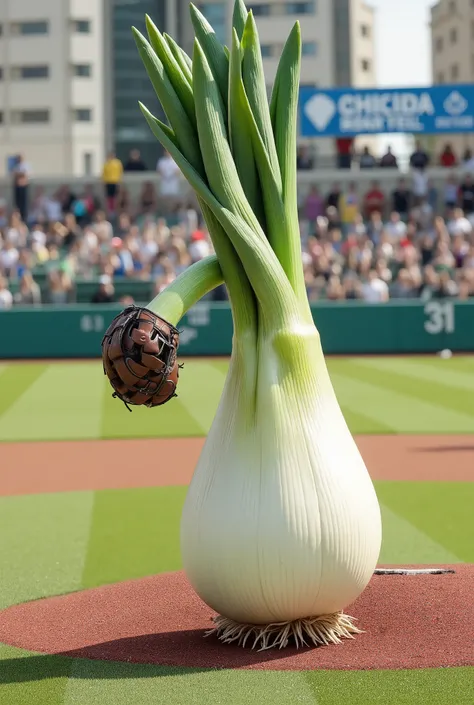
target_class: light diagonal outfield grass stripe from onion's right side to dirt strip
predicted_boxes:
[331,372,474,434]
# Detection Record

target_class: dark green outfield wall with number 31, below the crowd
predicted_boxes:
[0,300,474,359]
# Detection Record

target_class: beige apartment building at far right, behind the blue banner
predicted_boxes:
[431,0,474,155]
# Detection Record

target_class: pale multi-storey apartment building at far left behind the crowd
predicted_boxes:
[0,0,106,174]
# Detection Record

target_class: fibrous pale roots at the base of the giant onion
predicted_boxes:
[206,612,362,651]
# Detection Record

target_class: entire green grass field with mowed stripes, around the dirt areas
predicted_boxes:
[0,357,474,705]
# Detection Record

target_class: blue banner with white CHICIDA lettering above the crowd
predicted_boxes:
[300,83,474,137]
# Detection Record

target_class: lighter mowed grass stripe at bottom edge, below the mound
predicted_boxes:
[64,659,314,705]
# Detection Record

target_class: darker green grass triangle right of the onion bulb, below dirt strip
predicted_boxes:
[377,478,474,563]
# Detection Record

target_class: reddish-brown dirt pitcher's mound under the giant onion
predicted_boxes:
[0,564,474,670]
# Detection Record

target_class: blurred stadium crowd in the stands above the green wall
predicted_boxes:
[0,151,474,309]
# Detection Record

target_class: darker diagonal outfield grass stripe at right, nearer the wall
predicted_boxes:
[350,360,474,418]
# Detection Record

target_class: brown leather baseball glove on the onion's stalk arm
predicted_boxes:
[102,306,179,411]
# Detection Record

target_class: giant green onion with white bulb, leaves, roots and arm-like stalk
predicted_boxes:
[134,0,381,648]
